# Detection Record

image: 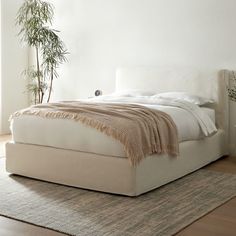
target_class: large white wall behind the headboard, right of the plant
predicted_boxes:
[51,0,236,99]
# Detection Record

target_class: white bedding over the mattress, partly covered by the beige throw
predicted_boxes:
[11,96,216,157]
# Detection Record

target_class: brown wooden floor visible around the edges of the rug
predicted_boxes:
[0,136,236,236]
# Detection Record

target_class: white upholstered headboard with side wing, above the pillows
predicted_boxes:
[116,67,232,147]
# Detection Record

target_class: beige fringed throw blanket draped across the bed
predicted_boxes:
[13,102,179,165]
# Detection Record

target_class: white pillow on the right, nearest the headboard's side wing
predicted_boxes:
[154,92,214,106]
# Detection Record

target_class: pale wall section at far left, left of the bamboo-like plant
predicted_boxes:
[0,0,28,133]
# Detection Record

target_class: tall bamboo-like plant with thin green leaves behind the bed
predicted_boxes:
[16,0,68,104]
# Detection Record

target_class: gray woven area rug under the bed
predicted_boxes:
[0,170,236,236]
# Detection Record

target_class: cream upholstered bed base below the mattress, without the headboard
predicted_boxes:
[6,130,227,196]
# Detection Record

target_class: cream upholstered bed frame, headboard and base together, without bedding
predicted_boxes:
[6,67,231,196]
